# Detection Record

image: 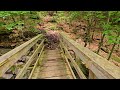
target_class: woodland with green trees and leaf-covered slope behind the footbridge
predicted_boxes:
[0,11,120,79]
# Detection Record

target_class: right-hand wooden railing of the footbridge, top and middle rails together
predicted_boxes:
[60,32,120,79]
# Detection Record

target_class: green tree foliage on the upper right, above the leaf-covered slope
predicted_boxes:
[56,11,120,47]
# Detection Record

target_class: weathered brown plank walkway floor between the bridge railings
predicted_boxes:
[38,48,73,79]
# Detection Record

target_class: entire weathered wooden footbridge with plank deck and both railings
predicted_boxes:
[0,32,120,79]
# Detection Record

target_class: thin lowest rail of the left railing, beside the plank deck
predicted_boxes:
[28,46,44,79]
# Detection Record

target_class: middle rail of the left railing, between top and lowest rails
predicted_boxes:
[15,40,44,79]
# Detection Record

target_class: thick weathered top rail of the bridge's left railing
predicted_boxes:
[0,35,42,77]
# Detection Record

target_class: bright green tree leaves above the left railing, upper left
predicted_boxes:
[0,11,37,33]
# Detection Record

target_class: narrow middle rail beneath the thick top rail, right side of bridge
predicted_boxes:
[60,40,86,79]
